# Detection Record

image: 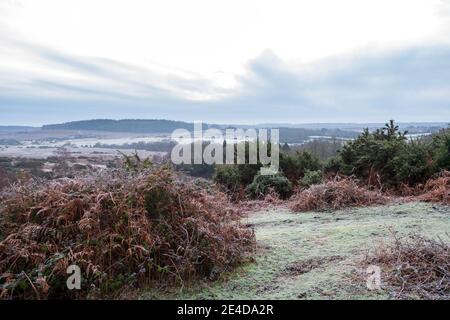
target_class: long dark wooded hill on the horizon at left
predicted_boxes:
[42,119,202,133]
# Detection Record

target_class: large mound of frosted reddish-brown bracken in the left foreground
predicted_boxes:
[0,168,254,299]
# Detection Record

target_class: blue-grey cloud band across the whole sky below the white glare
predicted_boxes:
[0,38,450,124]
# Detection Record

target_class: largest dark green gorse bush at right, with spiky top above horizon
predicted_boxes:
[336,120,444,187]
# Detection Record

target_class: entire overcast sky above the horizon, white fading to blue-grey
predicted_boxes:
[0,0,450,125]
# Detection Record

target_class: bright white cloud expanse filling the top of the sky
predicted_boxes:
[3,0,445,76]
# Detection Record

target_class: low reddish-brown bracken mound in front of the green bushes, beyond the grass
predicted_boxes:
[290,177,386,212]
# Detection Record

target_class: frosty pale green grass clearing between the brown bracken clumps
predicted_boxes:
[142,203,450,299]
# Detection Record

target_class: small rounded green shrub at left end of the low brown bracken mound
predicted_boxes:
[246,173,292,199]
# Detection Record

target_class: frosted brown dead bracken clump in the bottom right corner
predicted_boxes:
[365,235,450,299]
